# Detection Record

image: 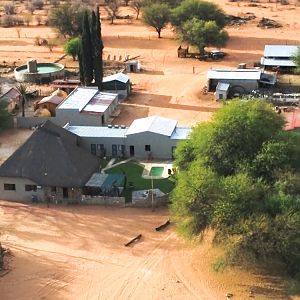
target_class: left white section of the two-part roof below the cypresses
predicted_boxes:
[58,87,98,111]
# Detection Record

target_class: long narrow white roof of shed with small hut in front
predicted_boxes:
[207,69,261,80]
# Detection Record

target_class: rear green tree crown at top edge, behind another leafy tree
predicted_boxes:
[171,0,226,30]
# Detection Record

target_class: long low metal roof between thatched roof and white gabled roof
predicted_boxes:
[66,126,128,138]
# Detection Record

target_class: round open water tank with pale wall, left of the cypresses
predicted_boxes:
[14,61,65,83]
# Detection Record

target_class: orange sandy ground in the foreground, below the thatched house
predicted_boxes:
[0,201,299,300]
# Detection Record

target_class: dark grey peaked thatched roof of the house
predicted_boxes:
[0,121,99,187]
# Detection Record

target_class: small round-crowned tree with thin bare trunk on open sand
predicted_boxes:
[142,3,170,38]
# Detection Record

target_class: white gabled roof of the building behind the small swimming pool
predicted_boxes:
[126,116,177,136]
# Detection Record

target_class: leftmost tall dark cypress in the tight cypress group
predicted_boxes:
[80,11,94,85]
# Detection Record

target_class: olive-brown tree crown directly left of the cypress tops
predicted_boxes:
[49,4,86,37]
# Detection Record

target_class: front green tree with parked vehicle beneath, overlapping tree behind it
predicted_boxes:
[180,18,228,54]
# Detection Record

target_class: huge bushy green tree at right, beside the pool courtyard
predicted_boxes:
[171,100,300,275]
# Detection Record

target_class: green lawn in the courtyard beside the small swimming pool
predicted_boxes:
[105,161,175,201]
